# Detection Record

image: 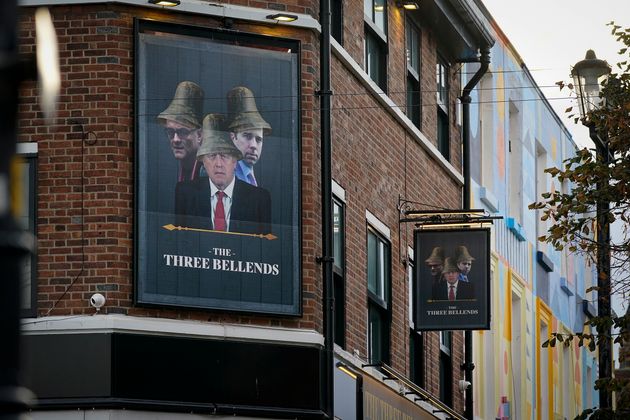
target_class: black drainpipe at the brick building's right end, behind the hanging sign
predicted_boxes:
[459,47,490,420]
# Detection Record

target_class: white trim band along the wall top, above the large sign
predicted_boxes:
[19,0,321,32]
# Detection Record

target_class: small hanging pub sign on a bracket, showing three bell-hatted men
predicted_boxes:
[414,228,490,330]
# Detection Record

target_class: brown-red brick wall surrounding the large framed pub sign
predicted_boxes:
[19,5,322,330]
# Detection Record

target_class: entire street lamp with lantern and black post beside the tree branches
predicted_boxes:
[571,50,612,408]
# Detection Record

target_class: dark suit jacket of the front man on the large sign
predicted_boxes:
[175,176,271,234]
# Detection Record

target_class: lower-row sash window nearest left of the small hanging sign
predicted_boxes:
[367,228,391,363]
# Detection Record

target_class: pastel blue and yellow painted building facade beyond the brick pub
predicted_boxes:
[469,4,598,419]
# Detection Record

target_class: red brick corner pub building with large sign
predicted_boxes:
[18,0,492,419]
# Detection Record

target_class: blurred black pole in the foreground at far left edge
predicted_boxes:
[0,0,32,419]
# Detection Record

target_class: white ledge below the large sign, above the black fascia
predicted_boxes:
[22,314,324,347]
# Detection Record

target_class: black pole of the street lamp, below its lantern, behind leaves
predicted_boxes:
[589,124,612,409]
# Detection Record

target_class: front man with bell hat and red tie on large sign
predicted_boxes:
[175,114,271,234]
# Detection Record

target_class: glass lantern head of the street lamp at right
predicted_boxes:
[571,50,610,121]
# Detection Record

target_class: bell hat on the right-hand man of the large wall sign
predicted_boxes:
[227,86,271,135]
